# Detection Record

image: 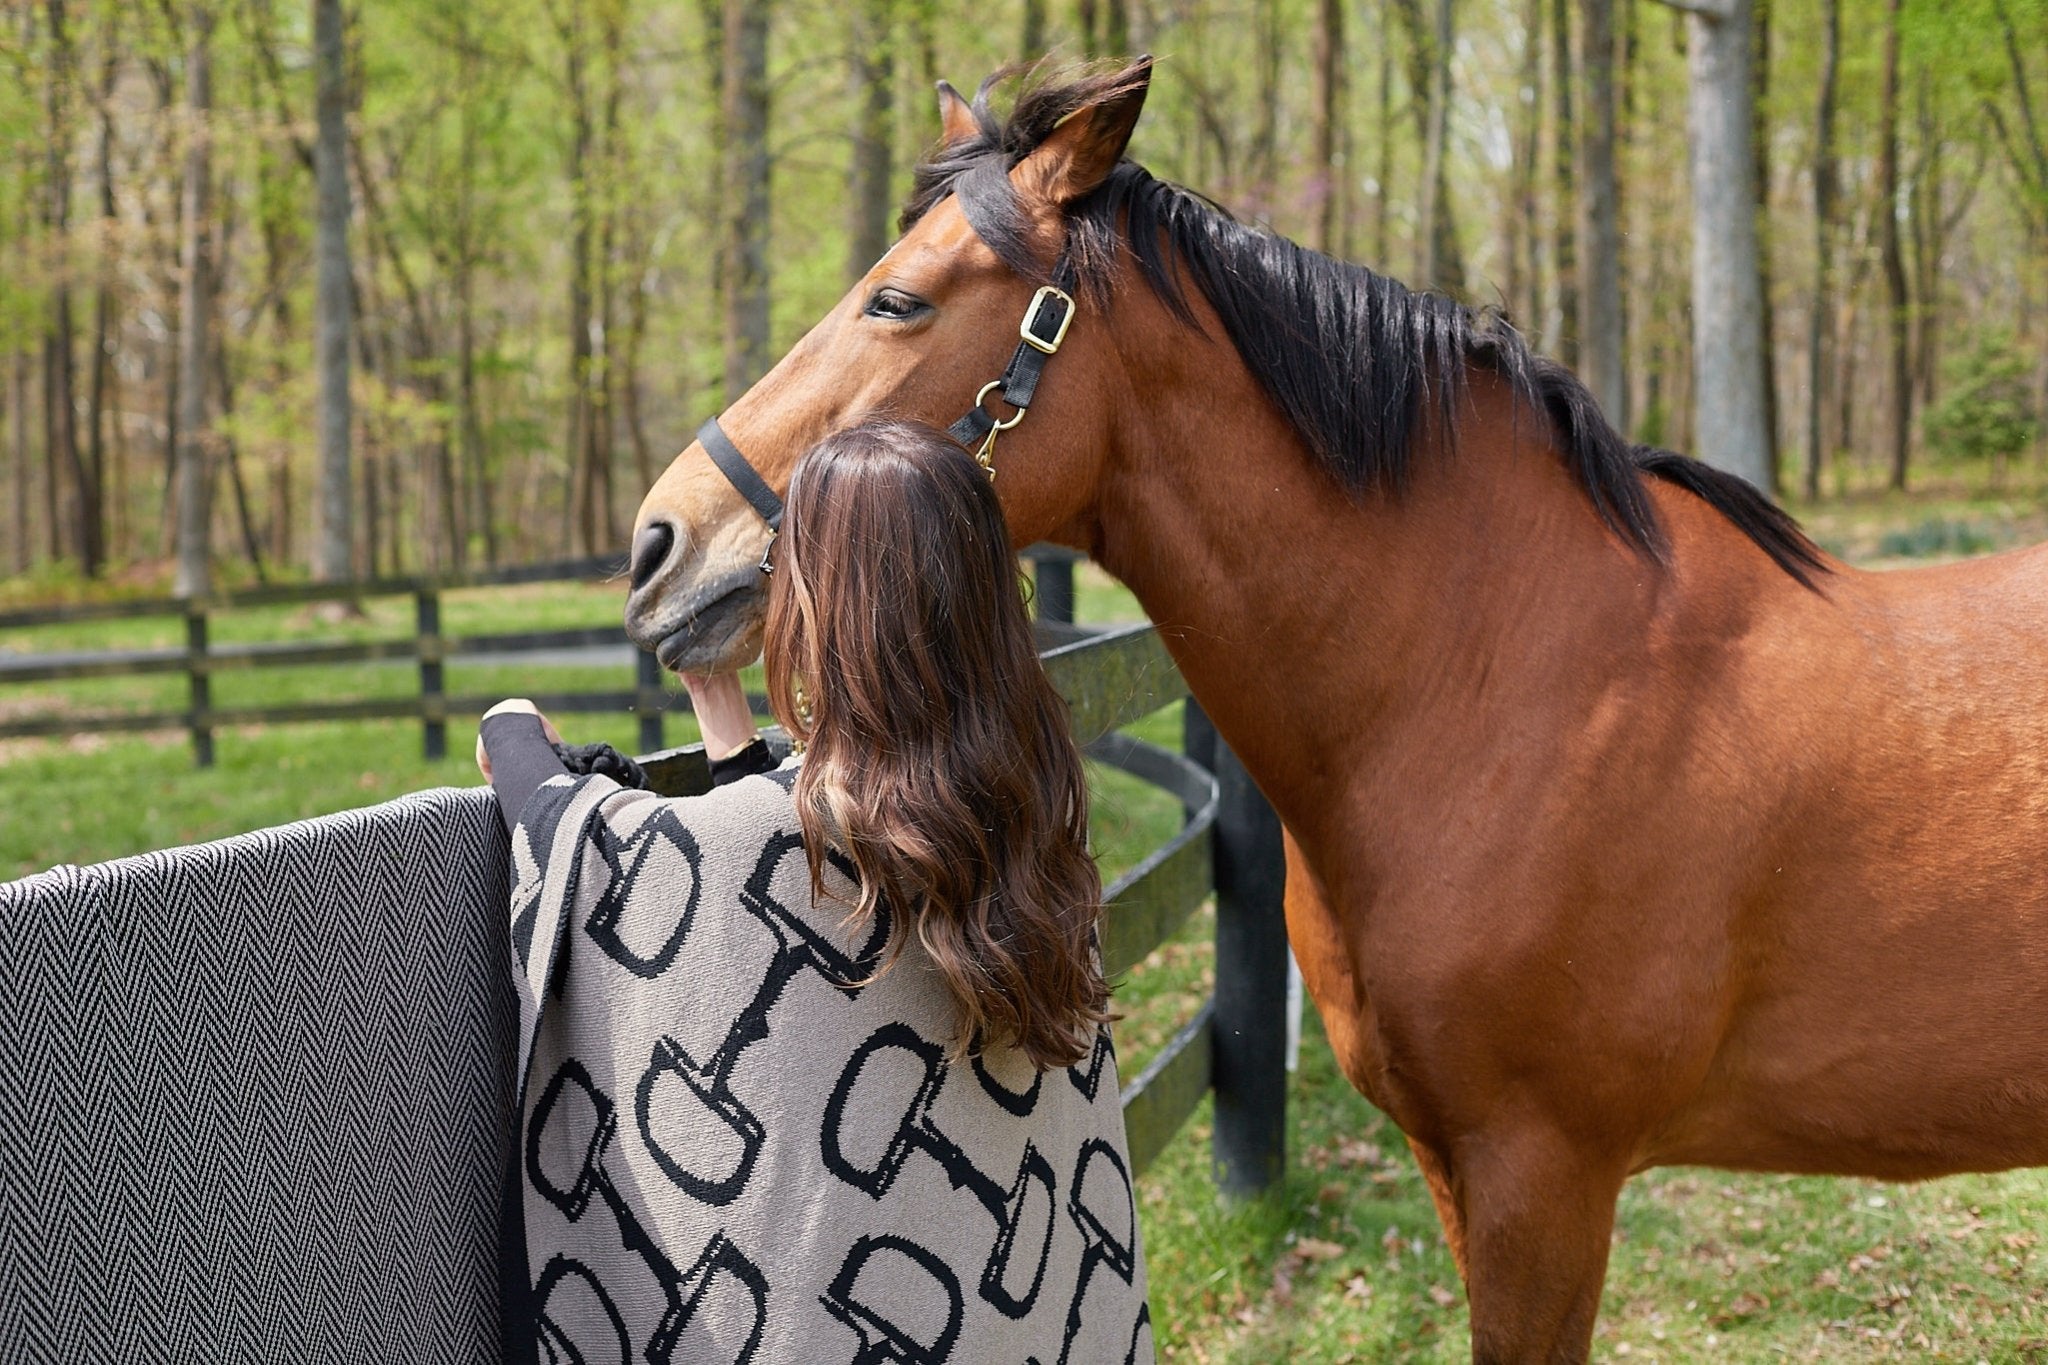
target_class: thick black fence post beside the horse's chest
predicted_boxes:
[1188,700,1288,1199]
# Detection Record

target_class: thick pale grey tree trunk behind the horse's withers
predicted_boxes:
[1686,0,1777,489]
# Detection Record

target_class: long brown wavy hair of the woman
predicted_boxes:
[764,422,1110,1068]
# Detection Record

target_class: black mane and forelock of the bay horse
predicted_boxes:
[901,65,1825,587]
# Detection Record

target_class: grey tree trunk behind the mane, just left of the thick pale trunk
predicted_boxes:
[1579,0,1628,432]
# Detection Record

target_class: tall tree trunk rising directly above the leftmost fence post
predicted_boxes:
[178,4,213,598]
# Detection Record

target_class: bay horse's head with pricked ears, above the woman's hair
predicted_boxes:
[627,59,1151,671]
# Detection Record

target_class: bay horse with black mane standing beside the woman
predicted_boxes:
[627,61,2048,1361]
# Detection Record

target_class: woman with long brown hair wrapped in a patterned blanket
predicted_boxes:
[479,424,1151,1365]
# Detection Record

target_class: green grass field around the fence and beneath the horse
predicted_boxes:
[0,491,2048,1365]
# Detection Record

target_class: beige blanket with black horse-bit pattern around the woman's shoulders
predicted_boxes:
[512,767,1153,1365]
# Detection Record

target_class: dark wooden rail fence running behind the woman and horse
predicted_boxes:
[0,546,1288,1197]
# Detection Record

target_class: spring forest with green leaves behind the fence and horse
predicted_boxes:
[0,0,2048,598]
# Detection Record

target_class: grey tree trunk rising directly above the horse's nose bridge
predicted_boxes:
[721,0,772,403]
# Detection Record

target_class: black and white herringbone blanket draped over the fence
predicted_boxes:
[0,790,524,1365]
